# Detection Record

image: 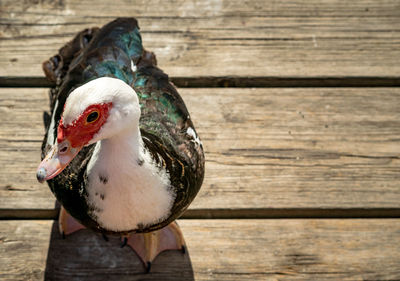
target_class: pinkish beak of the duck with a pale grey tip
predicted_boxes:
[36,139,83,183]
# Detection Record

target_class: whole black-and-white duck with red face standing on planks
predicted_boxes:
[36,18,205,272]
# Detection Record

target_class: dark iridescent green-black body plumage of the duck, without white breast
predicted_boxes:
[42,18,204,231]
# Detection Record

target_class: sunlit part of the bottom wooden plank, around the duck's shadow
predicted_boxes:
[0,219,400,280]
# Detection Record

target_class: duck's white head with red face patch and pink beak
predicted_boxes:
[36,77,140,182]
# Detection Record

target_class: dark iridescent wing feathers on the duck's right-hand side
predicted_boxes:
[133,56,204,228]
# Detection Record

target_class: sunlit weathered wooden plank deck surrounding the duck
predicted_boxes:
[0,0,400,280]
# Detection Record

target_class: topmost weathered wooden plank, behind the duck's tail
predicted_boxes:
[0,0,400,77]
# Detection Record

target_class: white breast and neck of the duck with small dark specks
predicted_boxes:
[87,128,175,231]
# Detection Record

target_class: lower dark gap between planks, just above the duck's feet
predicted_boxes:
[0,208,400,220]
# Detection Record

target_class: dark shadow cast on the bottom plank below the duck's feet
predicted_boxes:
[45,221,194,280]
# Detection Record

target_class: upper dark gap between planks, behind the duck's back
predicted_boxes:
[0,76,400,88]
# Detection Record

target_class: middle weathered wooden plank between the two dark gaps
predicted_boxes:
[0,88,400,213]
